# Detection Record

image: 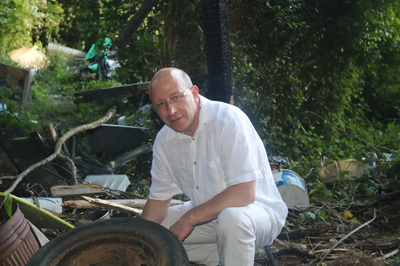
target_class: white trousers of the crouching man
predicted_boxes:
[161,202,276,266]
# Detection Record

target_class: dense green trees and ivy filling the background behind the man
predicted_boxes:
[0,0,400,187]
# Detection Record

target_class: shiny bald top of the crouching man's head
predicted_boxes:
[149,67,193,99]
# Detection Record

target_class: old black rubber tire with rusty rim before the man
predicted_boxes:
[27,217,189,266]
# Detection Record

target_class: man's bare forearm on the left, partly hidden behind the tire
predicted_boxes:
[140,198,172,224]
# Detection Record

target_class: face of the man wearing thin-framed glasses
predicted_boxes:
[151,79,199,136]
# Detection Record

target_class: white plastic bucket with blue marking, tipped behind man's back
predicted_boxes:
[272,169,310,209]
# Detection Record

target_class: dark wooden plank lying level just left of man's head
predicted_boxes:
[74,82,150,104]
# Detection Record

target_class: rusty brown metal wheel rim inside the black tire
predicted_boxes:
[50,232,165,266]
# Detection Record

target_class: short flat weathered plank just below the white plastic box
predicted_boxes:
[51,184,106,198]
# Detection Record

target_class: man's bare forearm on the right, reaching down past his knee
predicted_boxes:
[170,181,256,241]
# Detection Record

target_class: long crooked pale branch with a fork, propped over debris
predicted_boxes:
[5,107,116,193]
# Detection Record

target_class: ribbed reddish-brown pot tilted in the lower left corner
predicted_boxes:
[0,203,39,266]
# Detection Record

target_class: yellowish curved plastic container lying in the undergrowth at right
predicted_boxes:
[319,159,369,182]
